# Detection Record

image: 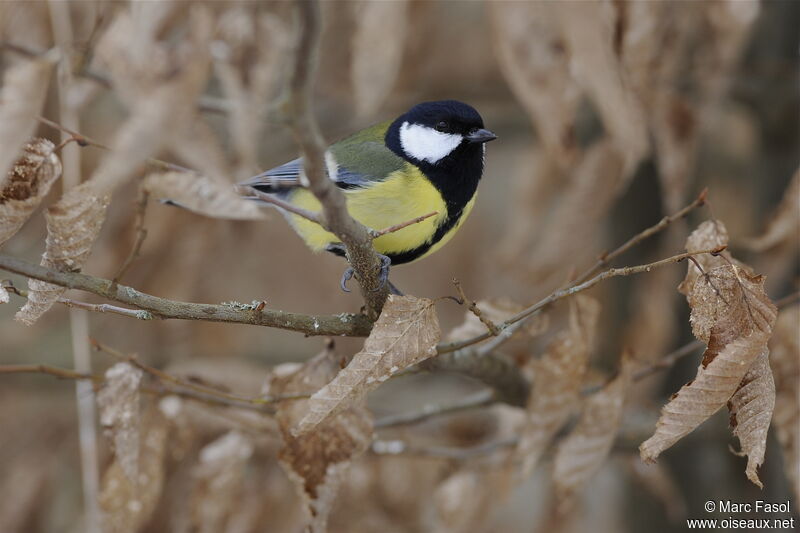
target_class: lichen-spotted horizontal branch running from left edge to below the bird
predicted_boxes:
[0,255,372,337]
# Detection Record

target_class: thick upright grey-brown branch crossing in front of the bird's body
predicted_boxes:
[284,0,389,318]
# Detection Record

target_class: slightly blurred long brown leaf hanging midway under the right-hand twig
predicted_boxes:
[515,294,600,477]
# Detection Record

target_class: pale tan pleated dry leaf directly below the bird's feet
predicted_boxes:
[292,296,441,435]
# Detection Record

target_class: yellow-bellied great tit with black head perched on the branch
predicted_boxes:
[238,100,497,294]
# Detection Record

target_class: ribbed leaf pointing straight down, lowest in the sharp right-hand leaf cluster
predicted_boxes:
[728,349,775,488]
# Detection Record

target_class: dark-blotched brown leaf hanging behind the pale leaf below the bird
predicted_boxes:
[269,342,372,531]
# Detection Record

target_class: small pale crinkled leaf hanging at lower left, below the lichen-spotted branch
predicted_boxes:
[97,363,144,484]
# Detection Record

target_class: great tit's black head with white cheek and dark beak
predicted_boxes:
[386,100,496,168]
